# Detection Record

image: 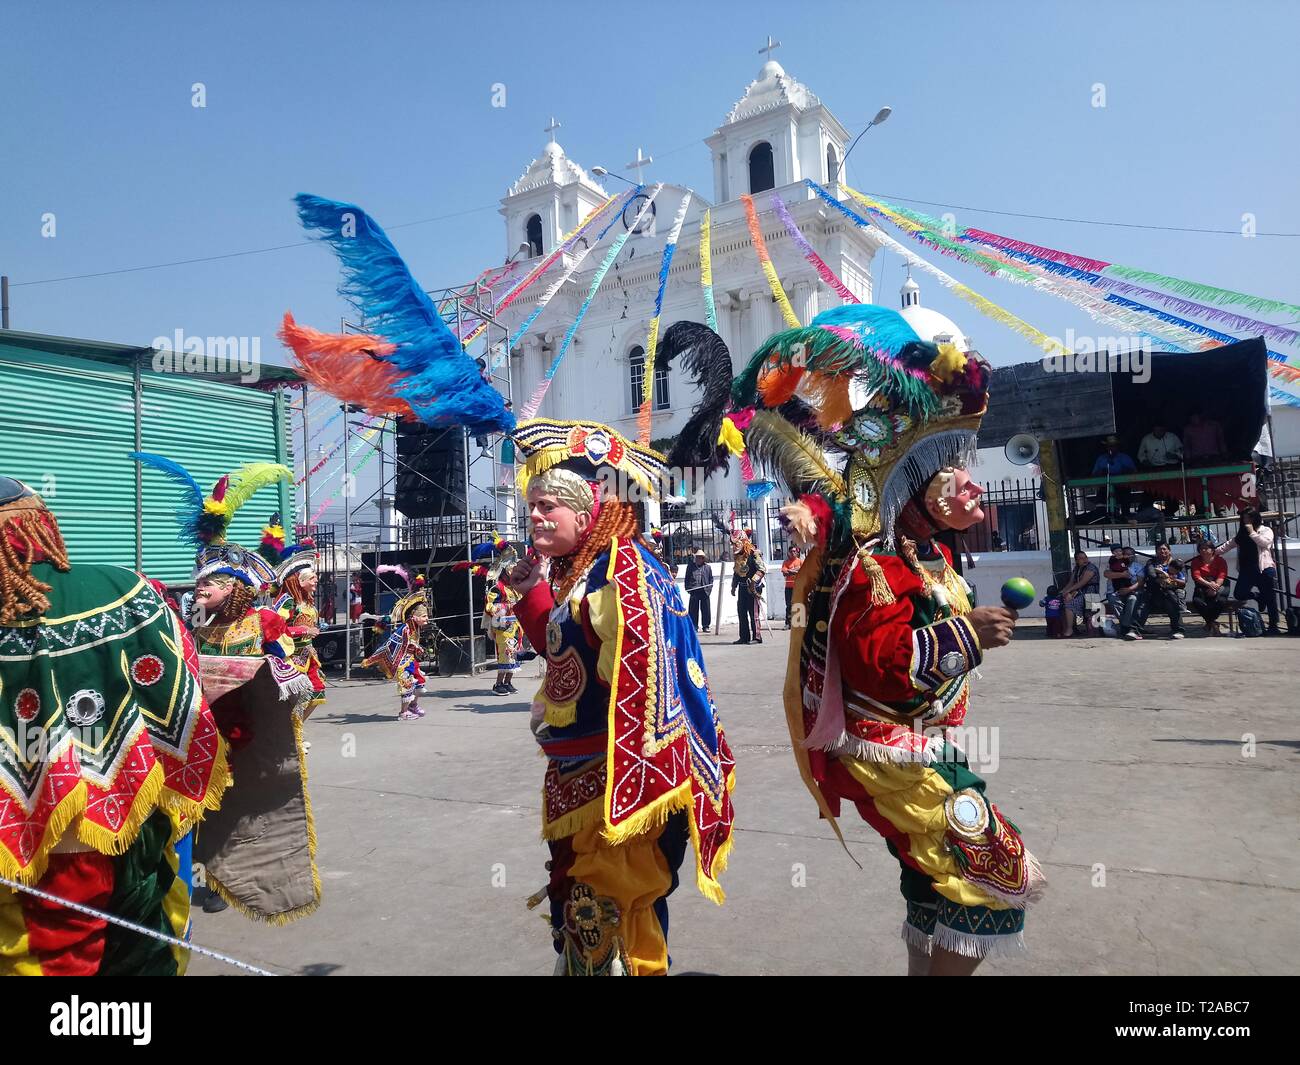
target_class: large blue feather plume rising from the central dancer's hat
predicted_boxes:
[294,192,515,433]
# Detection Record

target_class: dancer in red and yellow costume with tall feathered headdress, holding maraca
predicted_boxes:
[732,304,1043,958]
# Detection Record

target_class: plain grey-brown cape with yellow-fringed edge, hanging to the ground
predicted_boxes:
[194,654,321,925]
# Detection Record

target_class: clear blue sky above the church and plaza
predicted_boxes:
[0,0,1300,374]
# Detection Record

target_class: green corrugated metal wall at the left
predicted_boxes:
[0,342,293,583]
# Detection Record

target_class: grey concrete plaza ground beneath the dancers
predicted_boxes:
[191,622,1300,975]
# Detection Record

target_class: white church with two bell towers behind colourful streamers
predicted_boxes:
[501,53,970,499]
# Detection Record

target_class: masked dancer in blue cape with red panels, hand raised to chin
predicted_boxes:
[514,419,735,975]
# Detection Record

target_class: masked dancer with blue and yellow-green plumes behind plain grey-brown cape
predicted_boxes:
[133,454,321,925]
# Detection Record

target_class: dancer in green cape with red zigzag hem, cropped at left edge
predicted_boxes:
[0,477,230,975]
